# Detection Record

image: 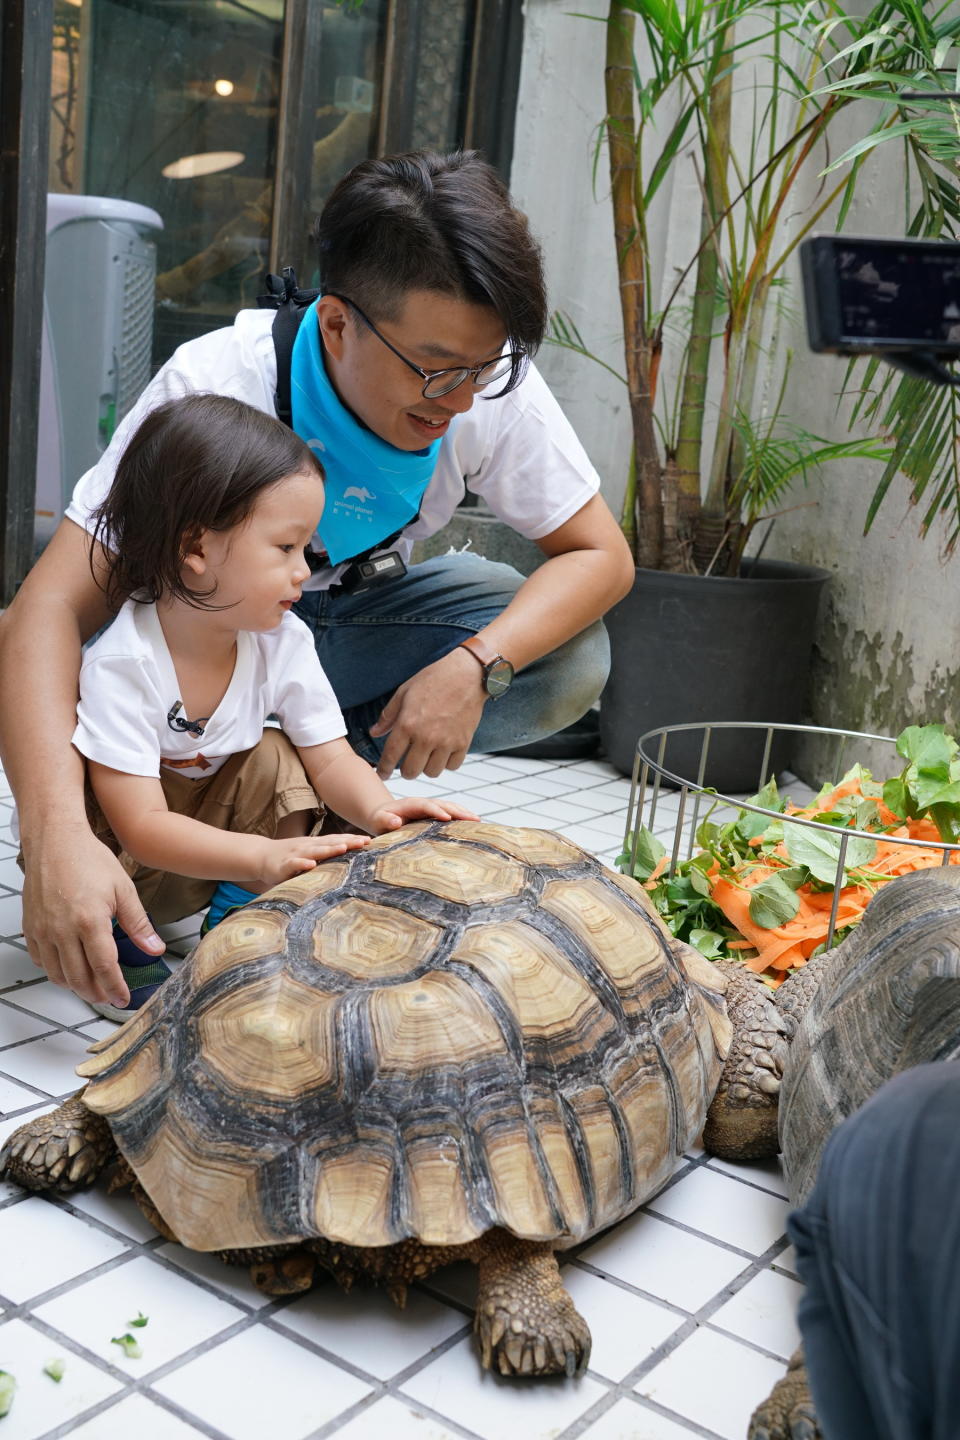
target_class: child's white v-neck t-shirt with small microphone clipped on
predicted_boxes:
[73,600,347,779]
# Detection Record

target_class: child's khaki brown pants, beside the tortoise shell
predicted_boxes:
[86,727,324,924]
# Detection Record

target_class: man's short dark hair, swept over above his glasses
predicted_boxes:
[314,150,547,393]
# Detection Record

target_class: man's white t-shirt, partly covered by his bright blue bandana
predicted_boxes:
[66,310,600,590]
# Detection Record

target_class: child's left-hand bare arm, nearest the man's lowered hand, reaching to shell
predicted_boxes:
[88,752,367,890]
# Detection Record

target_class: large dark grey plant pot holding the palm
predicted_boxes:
[600,560,830,792]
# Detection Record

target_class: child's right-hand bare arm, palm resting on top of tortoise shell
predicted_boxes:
[296,740,478,835]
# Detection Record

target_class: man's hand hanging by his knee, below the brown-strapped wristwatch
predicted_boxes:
[370,648,486,777]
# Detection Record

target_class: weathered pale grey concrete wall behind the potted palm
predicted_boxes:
[511,0,960,771]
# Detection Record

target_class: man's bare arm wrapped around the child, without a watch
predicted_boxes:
[0,520,164,1007]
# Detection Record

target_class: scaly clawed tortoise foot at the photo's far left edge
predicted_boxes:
[0,1090,117,1195]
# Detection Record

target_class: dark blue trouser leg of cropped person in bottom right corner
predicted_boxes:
[787,1061,960,1440]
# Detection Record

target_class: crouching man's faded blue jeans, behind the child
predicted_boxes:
[296,552,610,765]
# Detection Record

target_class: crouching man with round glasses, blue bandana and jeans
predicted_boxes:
[0,143,633,1008]
